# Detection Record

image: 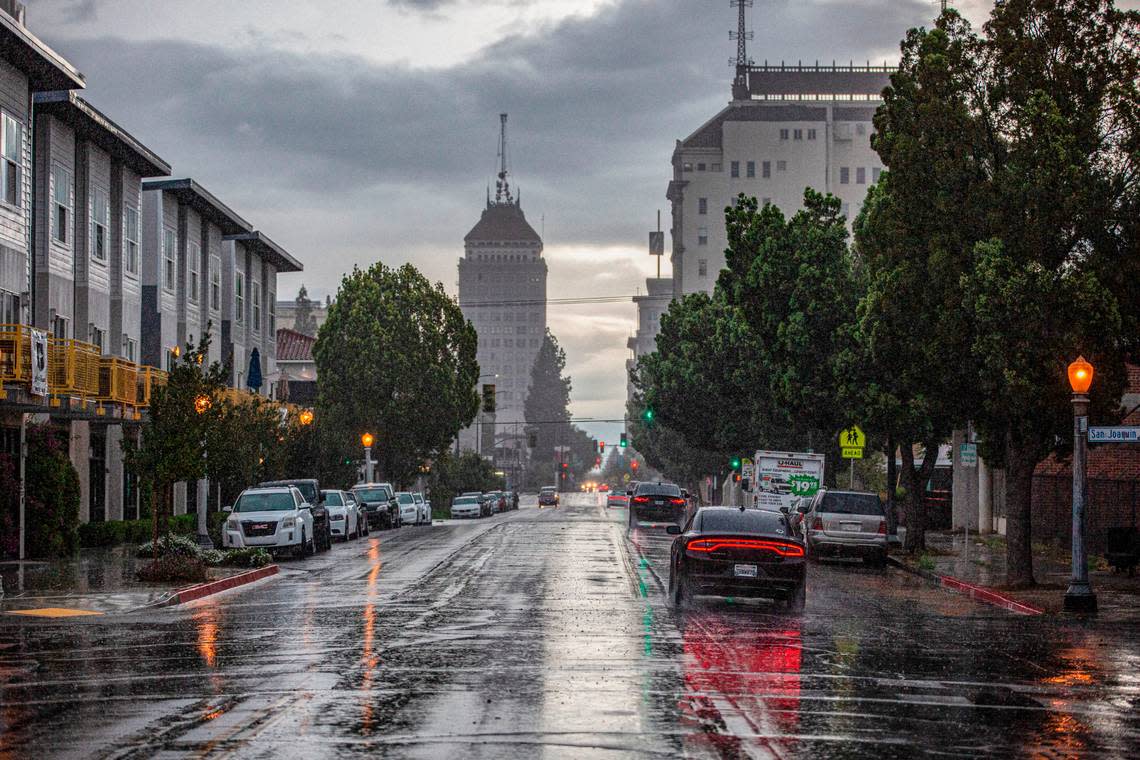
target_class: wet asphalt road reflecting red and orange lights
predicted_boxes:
[0,496,1140,759]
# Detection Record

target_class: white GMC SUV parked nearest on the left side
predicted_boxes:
[222,485,316,557]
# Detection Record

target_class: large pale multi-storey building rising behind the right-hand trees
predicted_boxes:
[666,65,894,297]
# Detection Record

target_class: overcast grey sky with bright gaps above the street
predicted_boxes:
[26,0,1007,441]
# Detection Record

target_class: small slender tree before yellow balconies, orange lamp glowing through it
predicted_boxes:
[123,329,228,559]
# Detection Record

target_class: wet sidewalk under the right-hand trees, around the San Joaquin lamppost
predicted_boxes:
[894,531,1140,621]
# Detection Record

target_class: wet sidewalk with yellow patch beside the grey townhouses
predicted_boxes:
[0,545,254,616]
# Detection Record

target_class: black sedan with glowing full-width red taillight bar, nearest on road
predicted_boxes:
[666,507,807,612]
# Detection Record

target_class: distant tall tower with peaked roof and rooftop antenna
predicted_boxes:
[459,114,546,471]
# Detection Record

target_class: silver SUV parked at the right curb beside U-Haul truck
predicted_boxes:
[797,489,887,565]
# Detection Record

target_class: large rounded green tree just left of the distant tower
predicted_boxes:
[314,263,479,483]
